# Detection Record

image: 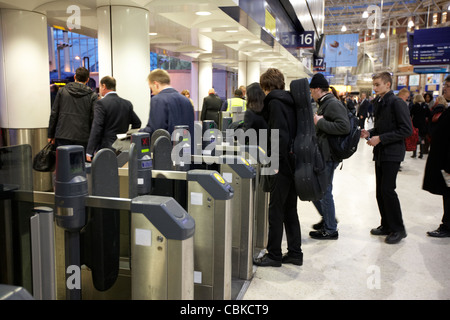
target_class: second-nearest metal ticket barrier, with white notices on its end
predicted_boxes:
[123,134,234,300]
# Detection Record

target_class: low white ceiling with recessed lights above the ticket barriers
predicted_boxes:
[0,0,310,77]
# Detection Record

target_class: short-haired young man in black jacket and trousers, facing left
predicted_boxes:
[361,72,413,244]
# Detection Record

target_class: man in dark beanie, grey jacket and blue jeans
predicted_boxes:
[309,73,350,240]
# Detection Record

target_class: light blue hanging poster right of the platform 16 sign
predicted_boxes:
[324,33,359,68]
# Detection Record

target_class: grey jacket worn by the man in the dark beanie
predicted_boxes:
[316,93,350,161]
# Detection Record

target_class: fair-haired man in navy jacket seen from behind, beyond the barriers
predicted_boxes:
[140,69,194,137]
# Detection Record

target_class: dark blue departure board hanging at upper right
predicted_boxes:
[410,27,450,65]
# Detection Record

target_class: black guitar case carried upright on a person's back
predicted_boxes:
[290,79,329,201]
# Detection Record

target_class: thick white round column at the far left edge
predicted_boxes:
[0,9,51,191]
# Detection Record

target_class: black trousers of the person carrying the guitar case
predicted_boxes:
[267,173,302,261]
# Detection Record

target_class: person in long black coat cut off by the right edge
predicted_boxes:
[423,76,450,238]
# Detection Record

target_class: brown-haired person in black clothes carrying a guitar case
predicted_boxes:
[253,68,303,267]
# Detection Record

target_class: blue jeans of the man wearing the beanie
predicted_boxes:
[313,161,339,233]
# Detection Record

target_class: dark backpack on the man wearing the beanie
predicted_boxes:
[327,102,361,160]
